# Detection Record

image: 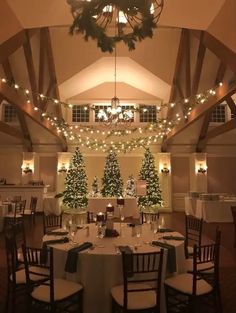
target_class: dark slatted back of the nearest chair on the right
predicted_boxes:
[193,230,221,295]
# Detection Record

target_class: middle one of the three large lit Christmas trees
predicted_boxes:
[101,150,123,197]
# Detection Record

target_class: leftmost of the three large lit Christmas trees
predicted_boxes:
[62,147,88,209]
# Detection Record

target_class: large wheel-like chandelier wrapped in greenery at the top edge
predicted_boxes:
[67,0,164,53]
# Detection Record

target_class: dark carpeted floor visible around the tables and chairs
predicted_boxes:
[0,213,236,313]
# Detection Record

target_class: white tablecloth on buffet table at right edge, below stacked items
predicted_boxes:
[196,200,236,223]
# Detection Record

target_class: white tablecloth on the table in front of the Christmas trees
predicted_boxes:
[88,198,139,218]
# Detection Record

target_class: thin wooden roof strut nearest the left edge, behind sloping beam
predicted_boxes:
[2,59,33,152]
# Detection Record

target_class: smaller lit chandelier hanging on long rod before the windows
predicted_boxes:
[97,46,134,126]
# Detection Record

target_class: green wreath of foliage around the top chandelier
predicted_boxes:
[67,0,163,53]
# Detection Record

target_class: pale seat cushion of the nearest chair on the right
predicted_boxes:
[165,273,212,296]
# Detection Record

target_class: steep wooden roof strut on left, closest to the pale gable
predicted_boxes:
[43,28,62,118]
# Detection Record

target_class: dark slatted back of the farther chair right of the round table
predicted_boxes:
[185,215,203,257]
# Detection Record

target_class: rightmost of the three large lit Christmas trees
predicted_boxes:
[138,149,163,209]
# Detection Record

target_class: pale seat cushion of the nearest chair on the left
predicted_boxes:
[31,278,83,303]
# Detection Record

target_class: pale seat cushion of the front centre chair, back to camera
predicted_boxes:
[111,283,156,310]
